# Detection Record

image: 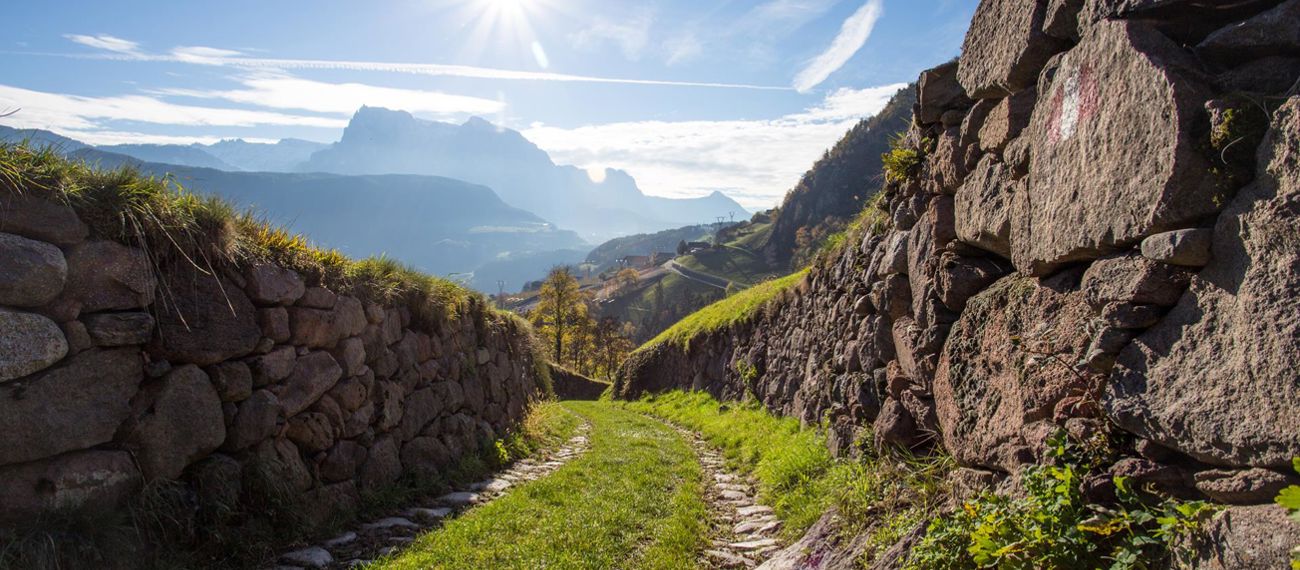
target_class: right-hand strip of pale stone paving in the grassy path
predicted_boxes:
[676,427,781,569]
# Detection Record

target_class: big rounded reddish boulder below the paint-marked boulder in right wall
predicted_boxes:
[935,272,1101,471]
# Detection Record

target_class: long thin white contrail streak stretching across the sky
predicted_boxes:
[61,32,790,91]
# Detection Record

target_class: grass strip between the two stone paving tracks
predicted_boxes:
[369,402,707,569]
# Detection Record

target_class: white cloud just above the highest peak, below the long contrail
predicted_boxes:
[156,74,506,117]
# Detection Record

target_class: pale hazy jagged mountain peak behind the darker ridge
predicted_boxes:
[302,107,748,241]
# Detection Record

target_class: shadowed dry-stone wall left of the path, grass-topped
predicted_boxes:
[0,195,545,524]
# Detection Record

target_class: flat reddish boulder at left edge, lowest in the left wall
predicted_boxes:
[0,450,140,523]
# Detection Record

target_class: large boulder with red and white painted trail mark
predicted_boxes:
[1011,21,1230,276]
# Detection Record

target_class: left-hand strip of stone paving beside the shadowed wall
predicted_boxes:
[273,423,590,570]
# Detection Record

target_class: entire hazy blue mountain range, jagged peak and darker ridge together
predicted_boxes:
[0,107,744,292]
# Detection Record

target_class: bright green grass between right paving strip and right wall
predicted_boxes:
[625,392,953,557]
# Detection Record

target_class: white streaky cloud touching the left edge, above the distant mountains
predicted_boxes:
[0,85,347,133]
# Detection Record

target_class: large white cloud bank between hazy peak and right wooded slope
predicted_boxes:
[524,83,905,208]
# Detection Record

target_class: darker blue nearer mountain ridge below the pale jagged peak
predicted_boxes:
[0,126,590,292]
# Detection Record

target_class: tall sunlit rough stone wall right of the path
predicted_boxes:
[619,0,1300,567]
